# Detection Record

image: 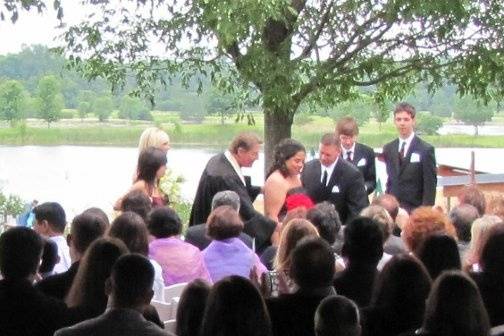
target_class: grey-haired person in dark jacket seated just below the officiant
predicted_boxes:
[184,190,253,250]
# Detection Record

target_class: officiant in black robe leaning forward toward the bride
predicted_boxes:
[189,133,276,247]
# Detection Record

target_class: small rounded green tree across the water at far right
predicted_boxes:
[454,97,494,135]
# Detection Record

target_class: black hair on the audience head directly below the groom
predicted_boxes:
[341,217,383,264]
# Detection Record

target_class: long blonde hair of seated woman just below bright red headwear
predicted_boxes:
[273,218,319,271]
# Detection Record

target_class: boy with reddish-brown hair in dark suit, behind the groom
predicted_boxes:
[336,117,376,195]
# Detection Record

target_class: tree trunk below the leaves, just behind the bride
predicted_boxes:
[264,107,294,173]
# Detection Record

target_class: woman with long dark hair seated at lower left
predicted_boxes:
[65,238,128,322]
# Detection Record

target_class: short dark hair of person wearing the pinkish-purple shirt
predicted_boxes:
[147,207,182,238]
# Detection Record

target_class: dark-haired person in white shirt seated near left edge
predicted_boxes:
[33,202,71,274]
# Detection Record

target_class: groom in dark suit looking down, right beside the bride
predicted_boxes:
[301,133,369,223]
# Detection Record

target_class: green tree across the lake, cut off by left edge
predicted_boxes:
[0,80,26,126]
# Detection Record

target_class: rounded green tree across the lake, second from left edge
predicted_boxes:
[36,75,64,127]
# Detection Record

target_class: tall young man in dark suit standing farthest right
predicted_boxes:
[383,103,437,212]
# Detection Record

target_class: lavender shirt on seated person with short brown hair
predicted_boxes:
[203,238,266,282]
